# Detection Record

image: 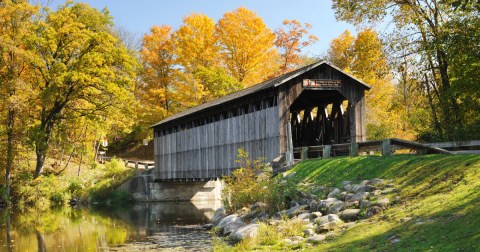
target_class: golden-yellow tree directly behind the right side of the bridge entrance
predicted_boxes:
[328,29,399,139]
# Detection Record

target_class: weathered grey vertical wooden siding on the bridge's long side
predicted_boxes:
[154,106,280,180]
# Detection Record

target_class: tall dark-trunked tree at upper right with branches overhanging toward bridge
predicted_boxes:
[333,0,479,140]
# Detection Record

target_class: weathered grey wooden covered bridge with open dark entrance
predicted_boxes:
[152,62,370,181]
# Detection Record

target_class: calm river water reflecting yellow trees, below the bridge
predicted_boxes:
[0,202,216,252]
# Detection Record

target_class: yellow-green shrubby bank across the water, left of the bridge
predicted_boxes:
[10,159,134,210]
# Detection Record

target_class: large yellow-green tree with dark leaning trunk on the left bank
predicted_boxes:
[32,3,136,177]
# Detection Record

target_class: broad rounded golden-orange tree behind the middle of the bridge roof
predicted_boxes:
[216,7,278,86]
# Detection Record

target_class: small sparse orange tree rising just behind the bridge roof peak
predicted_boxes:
[275,20,318,74]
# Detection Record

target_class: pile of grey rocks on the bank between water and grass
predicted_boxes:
[204,178,398,244]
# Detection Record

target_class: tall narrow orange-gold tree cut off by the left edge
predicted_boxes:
[0,0,38,196]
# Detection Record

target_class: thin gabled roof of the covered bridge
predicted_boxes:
[151,61,370,128]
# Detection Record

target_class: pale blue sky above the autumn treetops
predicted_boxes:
[48,0,356,56]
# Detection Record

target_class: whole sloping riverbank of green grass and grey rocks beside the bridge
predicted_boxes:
[213,155,480,251]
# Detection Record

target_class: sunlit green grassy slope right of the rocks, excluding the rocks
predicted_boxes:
[290,155,480,251]
